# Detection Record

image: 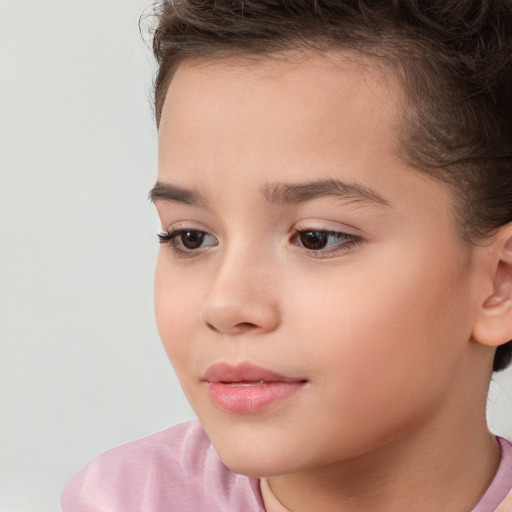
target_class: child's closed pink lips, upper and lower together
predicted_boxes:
[204,363,306,414]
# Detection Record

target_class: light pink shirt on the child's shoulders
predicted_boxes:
[62,420,512,512]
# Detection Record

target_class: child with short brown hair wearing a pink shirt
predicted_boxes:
[62,0,512,512]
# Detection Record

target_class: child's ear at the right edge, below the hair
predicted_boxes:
[473,224,512,347]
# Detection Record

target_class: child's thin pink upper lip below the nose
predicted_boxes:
[203,363,305,382]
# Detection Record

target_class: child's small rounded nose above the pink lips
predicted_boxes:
[201,251,280,335]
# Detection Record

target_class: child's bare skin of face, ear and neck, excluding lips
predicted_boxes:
[154,53,512,512]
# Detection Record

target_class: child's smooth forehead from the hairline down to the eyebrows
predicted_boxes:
[158,52,448,219]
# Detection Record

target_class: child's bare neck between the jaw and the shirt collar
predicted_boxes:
[262,414,500,512]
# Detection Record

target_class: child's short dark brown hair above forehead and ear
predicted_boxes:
[147,0,512,371]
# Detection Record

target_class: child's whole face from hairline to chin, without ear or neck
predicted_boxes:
[155,51,488,476]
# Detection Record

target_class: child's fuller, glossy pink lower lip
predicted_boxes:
[208,381,305,414]
